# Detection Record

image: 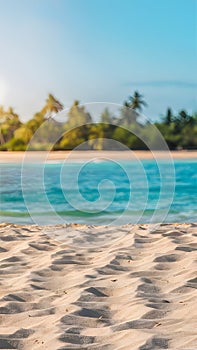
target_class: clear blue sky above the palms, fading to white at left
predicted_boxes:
[0,0,197,120]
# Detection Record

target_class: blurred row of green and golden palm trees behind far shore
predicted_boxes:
[0,91,197,151]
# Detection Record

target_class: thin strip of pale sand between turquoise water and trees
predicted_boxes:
[0,150,197,163]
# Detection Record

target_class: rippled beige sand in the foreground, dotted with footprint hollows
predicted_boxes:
[0,224,197,350]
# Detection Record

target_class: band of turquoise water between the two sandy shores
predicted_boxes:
[0,160,197,225]
